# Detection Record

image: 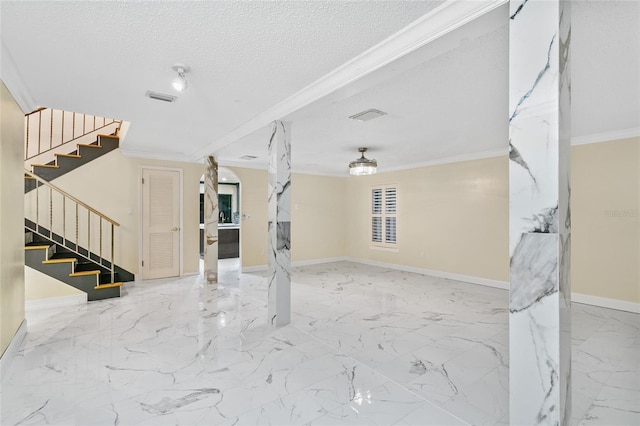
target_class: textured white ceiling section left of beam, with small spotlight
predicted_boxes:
[1,0,442,160]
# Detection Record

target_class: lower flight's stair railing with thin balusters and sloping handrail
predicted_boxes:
[24,170,120,283]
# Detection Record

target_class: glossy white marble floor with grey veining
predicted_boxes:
[0,260,640,426]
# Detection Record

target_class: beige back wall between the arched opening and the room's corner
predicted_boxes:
[229,167,347,267]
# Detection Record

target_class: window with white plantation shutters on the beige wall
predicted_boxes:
[371,185,398,248]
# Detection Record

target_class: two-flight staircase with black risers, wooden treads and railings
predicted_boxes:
[24,109,135,301]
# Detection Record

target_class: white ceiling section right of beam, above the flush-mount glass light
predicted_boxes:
[217,1,640,175]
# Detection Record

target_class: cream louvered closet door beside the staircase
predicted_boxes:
[142,169,182,279]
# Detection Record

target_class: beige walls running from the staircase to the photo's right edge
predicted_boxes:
[25,138,640,302]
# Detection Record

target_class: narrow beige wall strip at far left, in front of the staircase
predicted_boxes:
[0,83,24,354]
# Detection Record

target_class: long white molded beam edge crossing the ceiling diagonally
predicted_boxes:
[189,0,507,161]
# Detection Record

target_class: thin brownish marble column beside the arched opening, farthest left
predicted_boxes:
[204,156,219,284]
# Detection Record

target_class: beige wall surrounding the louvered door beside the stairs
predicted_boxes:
[53,150,204,274]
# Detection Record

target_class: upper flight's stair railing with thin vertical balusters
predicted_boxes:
[24,108,122,161]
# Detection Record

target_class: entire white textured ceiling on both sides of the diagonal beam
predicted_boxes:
[0,0,640,175]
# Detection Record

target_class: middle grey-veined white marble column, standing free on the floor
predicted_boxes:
[268,121,291,326]
